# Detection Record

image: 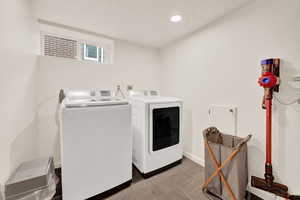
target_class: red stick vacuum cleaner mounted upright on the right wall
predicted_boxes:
[251,58,300,199]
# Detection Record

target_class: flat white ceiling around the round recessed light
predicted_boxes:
[33,0,249,47]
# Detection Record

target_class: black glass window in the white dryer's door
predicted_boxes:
[152,107,180,151]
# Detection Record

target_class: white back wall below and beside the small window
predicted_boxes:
[37,40,160,164]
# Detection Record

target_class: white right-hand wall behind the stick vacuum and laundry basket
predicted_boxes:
[161,0,300,197]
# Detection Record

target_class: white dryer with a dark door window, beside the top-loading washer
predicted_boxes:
[130,92,183,177]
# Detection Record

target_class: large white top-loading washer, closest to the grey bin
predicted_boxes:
[60,91,132,200]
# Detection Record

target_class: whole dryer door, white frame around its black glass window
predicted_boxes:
[150,103,181,153]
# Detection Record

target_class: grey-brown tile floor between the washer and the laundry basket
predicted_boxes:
[106,158,206,200]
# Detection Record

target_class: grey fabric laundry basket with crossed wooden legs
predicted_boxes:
[202,127,251,200]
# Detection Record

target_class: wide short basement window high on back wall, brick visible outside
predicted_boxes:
[41,32,113,64]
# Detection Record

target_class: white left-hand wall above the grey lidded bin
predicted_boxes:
[0,0,38,184]
